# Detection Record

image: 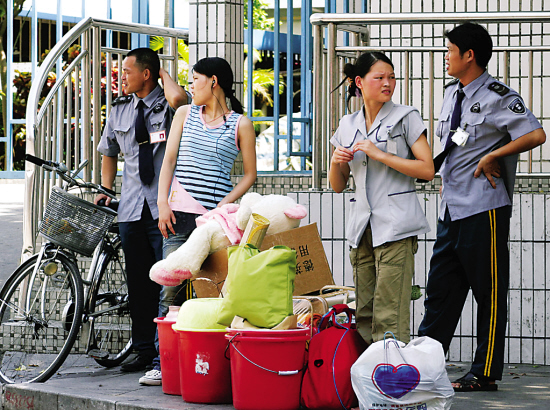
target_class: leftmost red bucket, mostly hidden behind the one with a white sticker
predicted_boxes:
[154,317,181,396]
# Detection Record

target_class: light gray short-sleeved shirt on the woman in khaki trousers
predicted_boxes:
[330,101,430,248]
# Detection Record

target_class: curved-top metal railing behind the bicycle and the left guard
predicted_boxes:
[23,18,188,254]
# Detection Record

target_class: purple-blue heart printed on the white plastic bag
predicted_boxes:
[372,363,420,399]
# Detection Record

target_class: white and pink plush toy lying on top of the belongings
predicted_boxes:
[149,192,307,286]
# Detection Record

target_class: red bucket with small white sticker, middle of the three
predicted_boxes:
[176,330,231,404]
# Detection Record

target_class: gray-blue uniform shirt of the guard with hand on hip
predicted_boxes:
[436,72,541,221]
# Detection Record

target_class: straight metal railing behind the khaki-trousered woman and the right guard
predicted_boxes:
[311,12,550,189]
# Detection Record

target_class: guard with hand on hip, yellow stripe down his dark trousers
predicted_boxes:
[418,23,546,392]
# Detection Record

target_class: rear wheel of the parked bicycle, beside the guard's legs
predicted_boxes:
[89,238,132,367]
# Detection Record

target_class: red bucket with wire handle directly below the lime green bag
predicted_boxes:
[226,329,310,410]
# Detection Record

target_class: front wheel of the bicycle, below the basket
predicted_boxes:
[0,252,84,383]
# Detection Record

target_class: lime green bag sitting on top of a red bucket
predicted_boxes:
[218,244,296,328]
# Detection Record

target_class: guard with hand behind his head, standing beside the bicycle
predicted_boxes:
[96,48,187,371]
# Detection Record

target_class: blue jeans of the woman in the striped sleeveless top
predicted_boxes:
[153,212,198,370]
